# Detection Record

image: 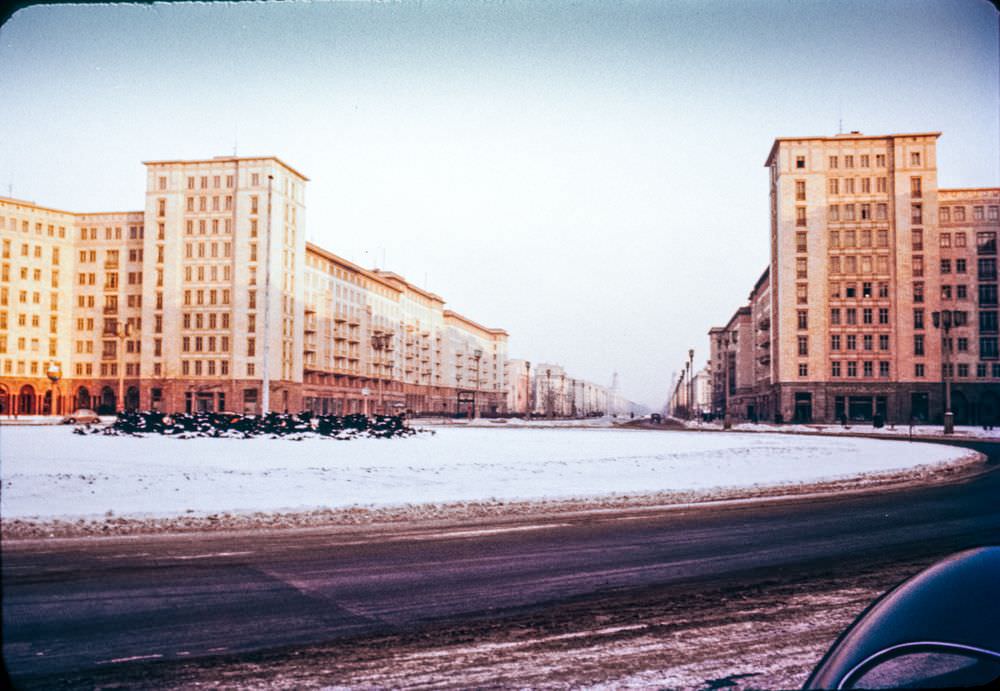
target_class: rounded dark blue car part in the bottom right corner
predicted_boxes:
[804,547,1000,689]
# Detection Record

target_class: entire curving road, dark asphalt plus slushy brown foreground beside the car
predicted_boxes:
[2,442,1000,688]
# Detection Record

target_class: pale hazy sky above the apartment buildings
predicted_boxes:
[0,0,1000,408]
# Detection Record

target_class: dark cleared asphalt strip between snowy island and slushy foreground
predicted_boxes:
[2,442,1000,686]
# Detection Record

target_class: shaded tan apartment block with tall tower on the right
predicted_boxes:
[710,132,1000,423]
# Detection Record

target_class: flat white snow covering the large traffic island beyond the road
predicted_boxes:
[0,427,970,524]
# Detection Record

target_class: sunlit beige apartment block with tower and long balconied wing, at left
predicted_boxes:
[0,156,507,415]
